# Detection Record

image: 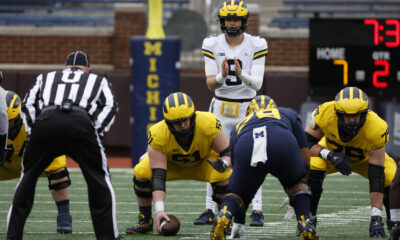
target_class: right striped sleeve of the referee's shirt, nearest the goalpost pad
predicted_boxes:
[94,78,118,135]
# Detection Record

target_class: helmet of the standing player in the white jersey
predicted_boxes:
[218,0,249,37]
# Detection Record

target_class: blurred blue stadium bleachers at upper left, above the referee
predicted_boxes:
[0,0,189,27]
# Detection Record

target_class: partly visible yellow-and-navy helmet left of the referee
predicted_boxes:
[6,91,22,139]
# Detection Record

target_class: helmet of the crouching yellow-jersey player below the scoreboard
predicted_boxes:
[334,87,368,142]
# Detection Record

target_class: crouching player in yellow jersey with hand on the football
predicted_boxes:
[126,92,231,234]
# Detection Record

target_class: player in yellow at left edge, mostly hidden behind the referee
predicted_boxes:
[0,91,72,233]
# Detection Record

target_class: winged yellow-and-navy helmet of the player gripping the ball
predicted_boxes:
[163,92,196,138]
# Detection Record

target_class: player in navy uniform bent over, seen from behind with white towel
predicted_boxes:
[211,95,318,240]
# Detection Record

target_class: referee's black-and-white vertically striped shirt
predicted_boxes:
[21,68,118,135]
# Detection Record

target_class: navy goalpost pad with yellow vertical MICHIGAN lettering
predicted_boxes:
[131,36,181,166]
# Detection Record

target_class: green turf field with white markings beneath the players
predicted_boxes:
[0,170,388,240]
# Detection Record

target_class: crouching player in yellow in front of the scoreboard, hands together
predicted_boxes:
[306,87,396,237]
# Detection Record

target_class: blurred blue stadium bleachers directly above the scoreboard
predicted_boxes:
[269,0,400,28]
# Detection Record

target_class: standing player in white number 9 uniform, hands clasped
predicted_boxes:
[199,0,268,226]
